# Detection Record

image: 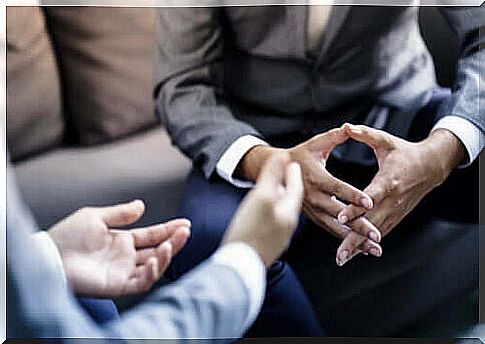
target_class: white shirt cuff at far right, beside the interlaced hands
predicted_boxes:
[433,116,485,167]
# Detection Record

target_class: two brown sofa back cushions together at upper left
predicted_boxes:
[7,7,157,160]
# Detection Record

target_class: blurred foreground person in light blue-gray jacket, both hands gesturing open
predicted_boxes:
[4,155,310,339]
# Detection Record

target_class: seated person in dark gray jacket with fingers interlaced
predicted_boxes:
[155,1,485,336]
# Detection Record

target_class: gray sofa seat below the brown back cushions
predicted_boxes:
[15,128,191,228]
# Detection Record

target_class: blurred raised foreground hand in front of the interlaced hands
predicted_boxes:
[223,153,303,267]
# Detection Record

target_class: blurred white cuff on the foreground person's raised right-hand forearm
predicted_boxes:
[210,242,266,329]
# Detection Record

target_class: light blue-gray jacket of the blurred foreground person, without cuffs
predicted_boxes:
[7,168,253,339]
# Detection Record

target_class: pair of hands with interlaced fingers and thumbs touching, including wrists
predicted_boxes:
[236,124,465,266]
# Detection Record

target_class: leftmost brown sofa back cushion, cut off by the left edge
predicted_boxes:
[6,7,64,160]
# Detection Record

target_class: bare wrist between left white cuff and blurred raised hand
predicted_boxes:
[234,145,282,182]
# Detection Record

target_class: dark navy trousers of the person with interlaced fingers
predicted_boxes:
[165,87,478,336]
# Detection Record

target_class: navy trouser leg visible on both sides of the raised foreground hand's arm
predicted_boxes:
[166,171,324,337]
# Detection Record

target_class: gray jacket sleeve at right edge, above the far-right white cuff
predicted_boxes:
[438,4,485,132]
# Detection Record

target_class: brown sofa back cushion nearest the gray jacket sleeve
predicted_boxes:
[45,7,157,144]
